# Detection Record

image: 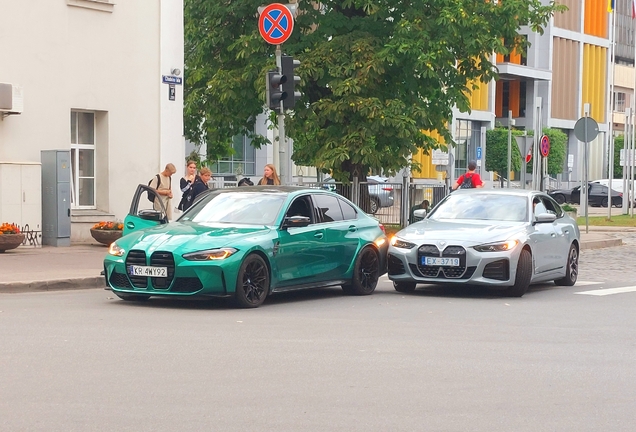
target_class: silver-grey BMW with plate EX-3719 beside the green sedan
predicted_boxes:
[388,189,580,297]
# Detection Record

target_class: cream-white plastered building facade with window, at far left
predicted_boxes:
[0,0,185,243]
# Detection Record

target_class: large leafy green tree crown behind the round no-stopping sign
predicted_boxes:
[185,0,565,181]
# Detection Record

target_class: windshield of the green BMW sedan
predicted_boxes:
[179,192,287,225]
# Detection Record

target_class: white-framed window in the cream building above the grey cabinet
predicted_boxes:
[71,111,95,209]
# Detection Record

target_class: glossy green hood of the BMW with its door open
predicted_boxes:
[117,221,271,253]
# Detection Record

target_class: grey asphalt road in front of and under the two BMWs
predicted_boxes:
[0,239,636,432]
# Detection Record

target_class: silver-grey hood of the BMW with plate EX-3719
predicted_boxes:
[396,219,526,245]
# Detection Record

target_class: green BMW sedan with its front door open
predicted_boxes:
[104,185,388,308]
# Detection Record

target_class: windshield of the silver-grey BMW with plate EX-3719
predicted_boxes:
[428,193,528,222]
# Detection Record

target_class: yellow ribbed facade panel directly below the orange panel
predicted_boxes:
[580,44,607,123]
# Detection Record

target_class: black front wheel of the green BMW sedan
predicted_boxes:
[234,254,269,308]
